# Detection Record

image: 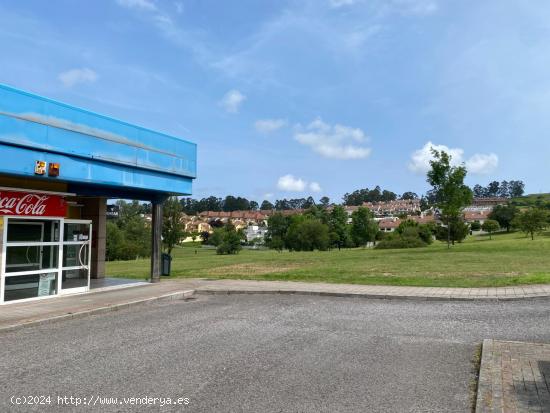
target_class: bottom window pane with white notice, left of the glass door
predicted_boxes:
[4,273,57,301]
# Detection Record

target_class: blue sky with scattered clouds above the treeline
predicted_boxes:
[0,0,550,202]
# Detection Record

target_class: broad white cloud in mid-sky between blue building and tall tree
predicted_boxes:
[294,118,371,159]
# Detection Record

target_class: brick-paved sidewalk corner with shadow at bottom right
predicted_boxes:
[476,340,550,413]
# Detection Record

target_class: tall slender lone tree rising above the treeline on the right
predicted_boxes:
[427,148,472,248]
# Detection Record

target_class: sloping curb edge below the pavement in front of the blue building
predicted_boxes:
[0,290,195,334]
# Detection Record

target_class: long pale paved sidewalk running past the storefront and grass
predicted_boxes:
[0,279,550,332]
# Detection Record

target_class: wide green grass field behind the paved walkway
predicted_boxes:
[107,233,550,287]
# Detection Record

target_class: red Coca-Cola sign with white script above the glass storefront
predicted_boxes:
[0,191,67,217]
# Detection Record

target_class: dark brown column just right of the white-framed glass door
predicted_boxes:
[78,197,107,278]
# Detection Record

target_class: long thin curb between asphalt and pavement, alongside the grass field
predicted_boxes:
[195,287,550,303]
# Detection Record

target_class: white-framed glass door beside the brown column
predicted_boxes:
[60,219,92,294]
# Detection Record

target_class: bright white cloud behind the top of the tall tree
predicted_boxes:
[409,142,498,175]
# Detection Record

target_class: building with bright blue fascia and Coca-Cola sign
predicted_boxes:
[0,84,197,304]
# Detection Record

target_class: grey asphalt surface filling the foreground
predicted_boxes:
[0,295,550,412]
